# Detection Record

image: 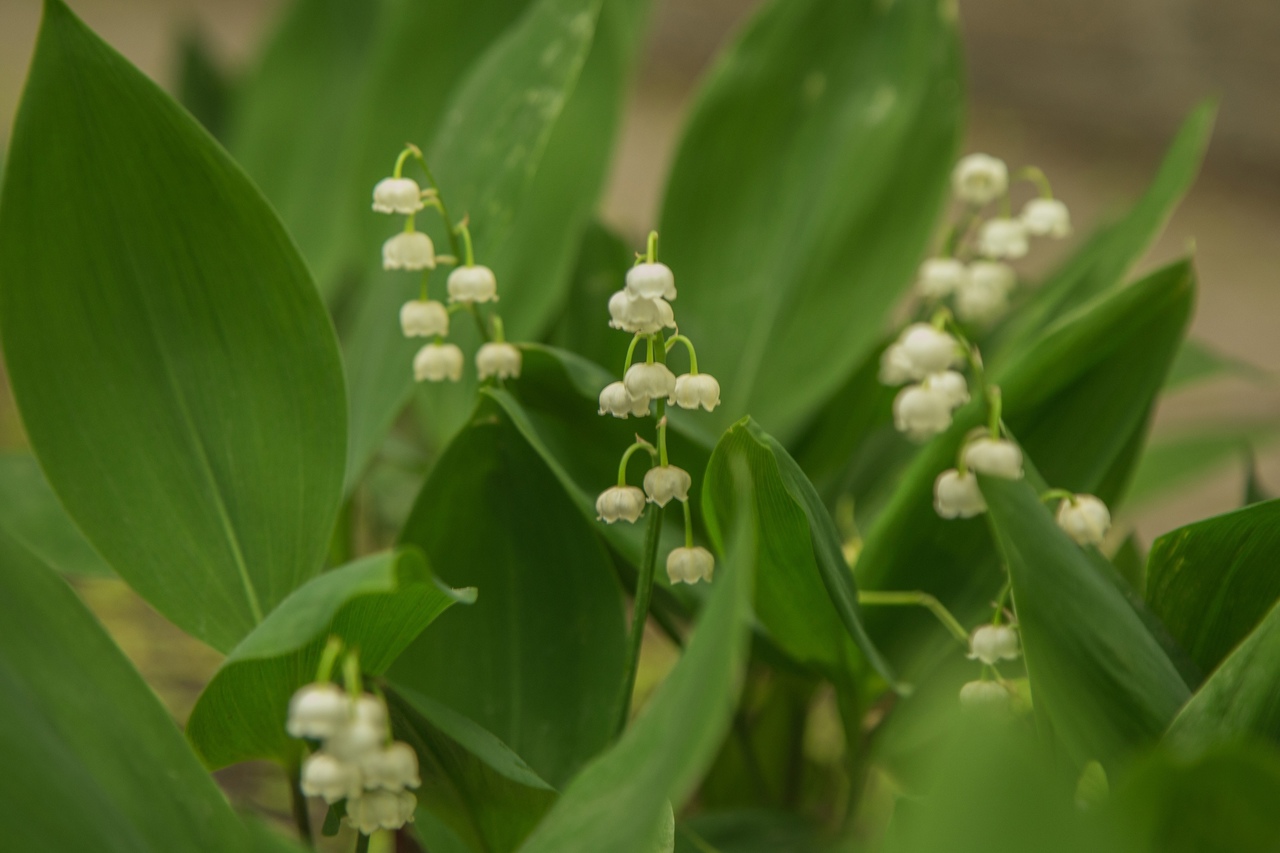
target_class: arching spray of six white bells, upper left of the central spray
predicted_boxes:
[374,145,521,382]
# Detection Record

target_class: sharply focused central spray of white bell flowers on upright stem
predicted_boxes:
[595,233,719,584]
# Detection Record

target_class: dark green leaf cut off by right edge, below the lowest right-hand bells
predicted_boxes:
[1147,501,1280,672]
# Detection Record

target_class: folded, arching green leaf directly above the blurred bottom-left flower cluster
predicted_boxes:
[187,548,475,770]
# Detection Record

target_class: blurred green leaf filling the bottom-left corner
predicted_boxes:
[0,533,246,853]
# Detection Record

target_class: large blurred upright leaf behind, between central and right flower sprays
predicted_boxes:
[662,0,964,441]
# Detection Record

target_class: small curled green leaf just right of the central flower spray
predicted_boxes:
[703,418,893,683]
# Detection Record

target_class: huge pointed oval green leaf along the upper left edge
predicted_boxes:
[0,0,346,651]
